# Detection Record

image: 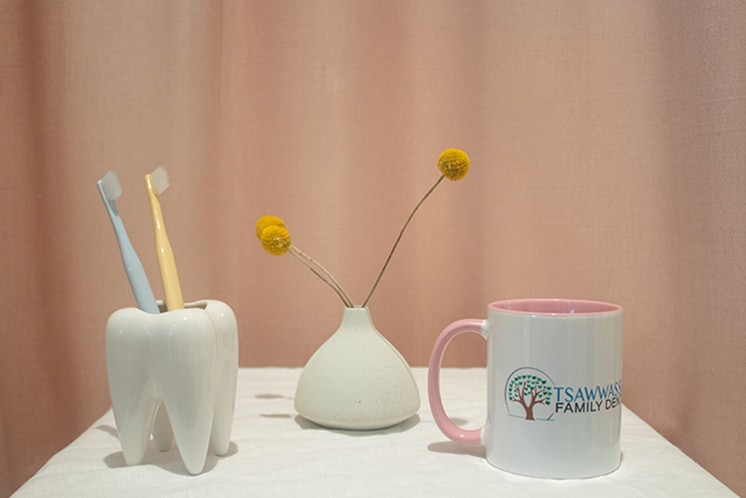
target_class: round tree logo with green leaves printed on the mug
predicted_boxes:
[505,367,554,420]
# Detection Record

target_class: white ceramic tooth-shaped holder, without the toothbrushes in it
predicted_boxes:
[106,300,238,474]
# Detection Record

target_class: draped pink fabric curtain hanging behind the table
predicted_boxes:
[0,0,746,495]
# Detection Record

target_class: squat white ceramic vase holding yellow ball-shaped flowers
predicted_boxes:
[295,307,420,430]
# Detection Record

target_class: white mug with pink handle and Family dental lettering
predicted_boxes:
[428,299,622,479]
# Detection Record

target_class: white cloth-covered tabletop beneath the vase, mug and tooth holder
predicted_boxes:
[13,368,736,498]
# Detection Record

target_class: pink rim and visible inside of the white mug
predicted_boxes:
[488,298,622,317]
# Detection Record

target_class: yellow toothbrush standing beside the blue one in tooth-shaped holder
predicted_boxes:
[145,167,184,310]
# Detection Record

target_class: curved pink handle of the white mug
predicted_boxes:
[427,318,485,444]
